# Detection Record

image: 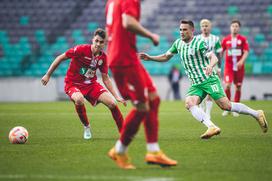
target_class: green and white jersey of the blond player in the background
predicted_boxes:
[196,34,223,53]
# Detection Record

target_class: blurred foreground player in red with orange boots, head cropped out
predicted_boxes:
[106,0,177,169]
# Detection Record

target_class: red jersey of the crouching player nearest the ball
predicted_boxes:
[65,44,108,84]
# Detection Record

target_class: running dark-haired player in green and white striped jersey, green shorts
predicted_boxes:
[139,20,268,139]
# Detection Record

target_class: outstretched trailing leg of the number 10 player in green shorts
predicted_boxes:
[215,93,268,133]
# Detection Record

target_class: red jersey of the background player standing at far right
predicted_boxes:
[222,34,249,71]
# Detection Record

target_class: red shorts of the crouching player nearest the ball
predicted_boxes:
[64,82,107,106]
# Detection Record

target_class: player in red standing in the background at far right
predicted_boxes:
[222,20,249,117]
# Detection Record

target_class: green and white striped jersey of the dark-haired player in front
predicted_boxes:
[167,37,216,85]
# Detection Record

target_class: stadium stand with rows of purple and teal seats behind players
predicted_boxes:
[0,0,272,77]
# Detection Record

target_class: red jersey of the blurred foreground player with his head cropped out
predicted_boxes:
[106,0,140,67]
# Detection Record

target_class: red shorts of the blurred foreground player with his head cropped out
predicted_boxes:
[111,64,157,104]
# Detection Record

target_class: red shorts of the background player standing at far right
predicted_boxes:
[224,68,245,85]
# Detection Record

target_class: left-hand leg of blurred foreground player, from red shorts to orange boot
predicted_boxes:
[108,67,149,169]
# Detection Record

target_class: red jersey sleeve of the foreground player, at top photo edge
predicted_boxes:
[121,0,140,18]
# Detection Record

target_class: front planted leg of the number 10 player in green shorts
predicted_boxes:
[185,94,221,139]
